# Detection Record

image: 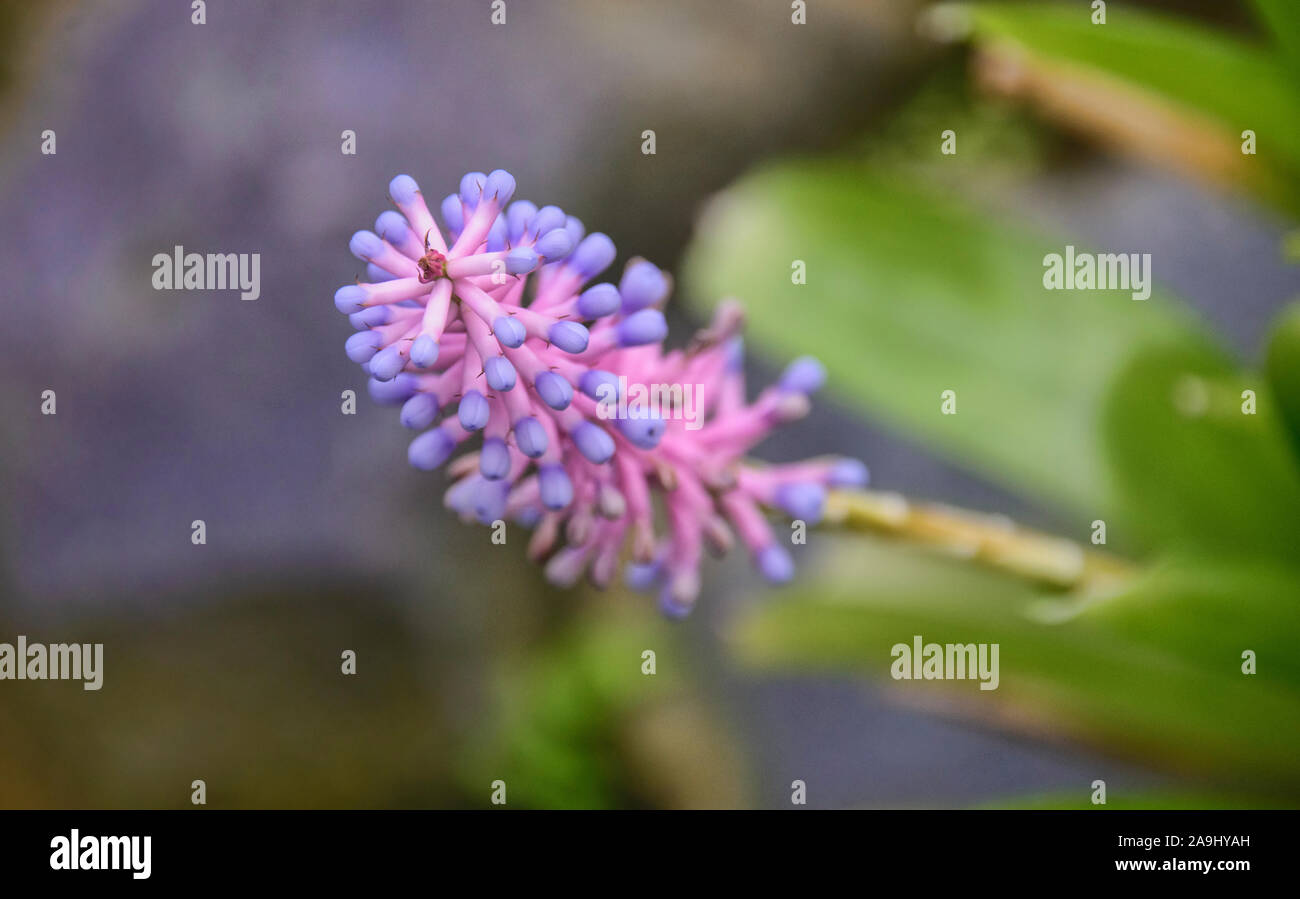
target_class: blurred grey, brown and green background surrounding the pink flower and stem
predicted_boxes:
[0,0,1300,808]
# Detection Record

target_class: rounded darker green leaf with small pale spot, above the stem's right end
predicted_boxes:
[1101,347,1300,560]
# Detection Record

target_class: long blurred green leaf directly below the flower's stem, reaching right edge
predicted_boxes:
[732,539,1300,803]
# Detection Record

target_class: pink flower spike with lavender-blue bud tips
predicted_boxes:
[334,170,867,616]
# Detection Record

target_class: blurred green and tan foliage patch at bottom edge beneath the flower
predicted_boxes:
[460,607,745,808]
